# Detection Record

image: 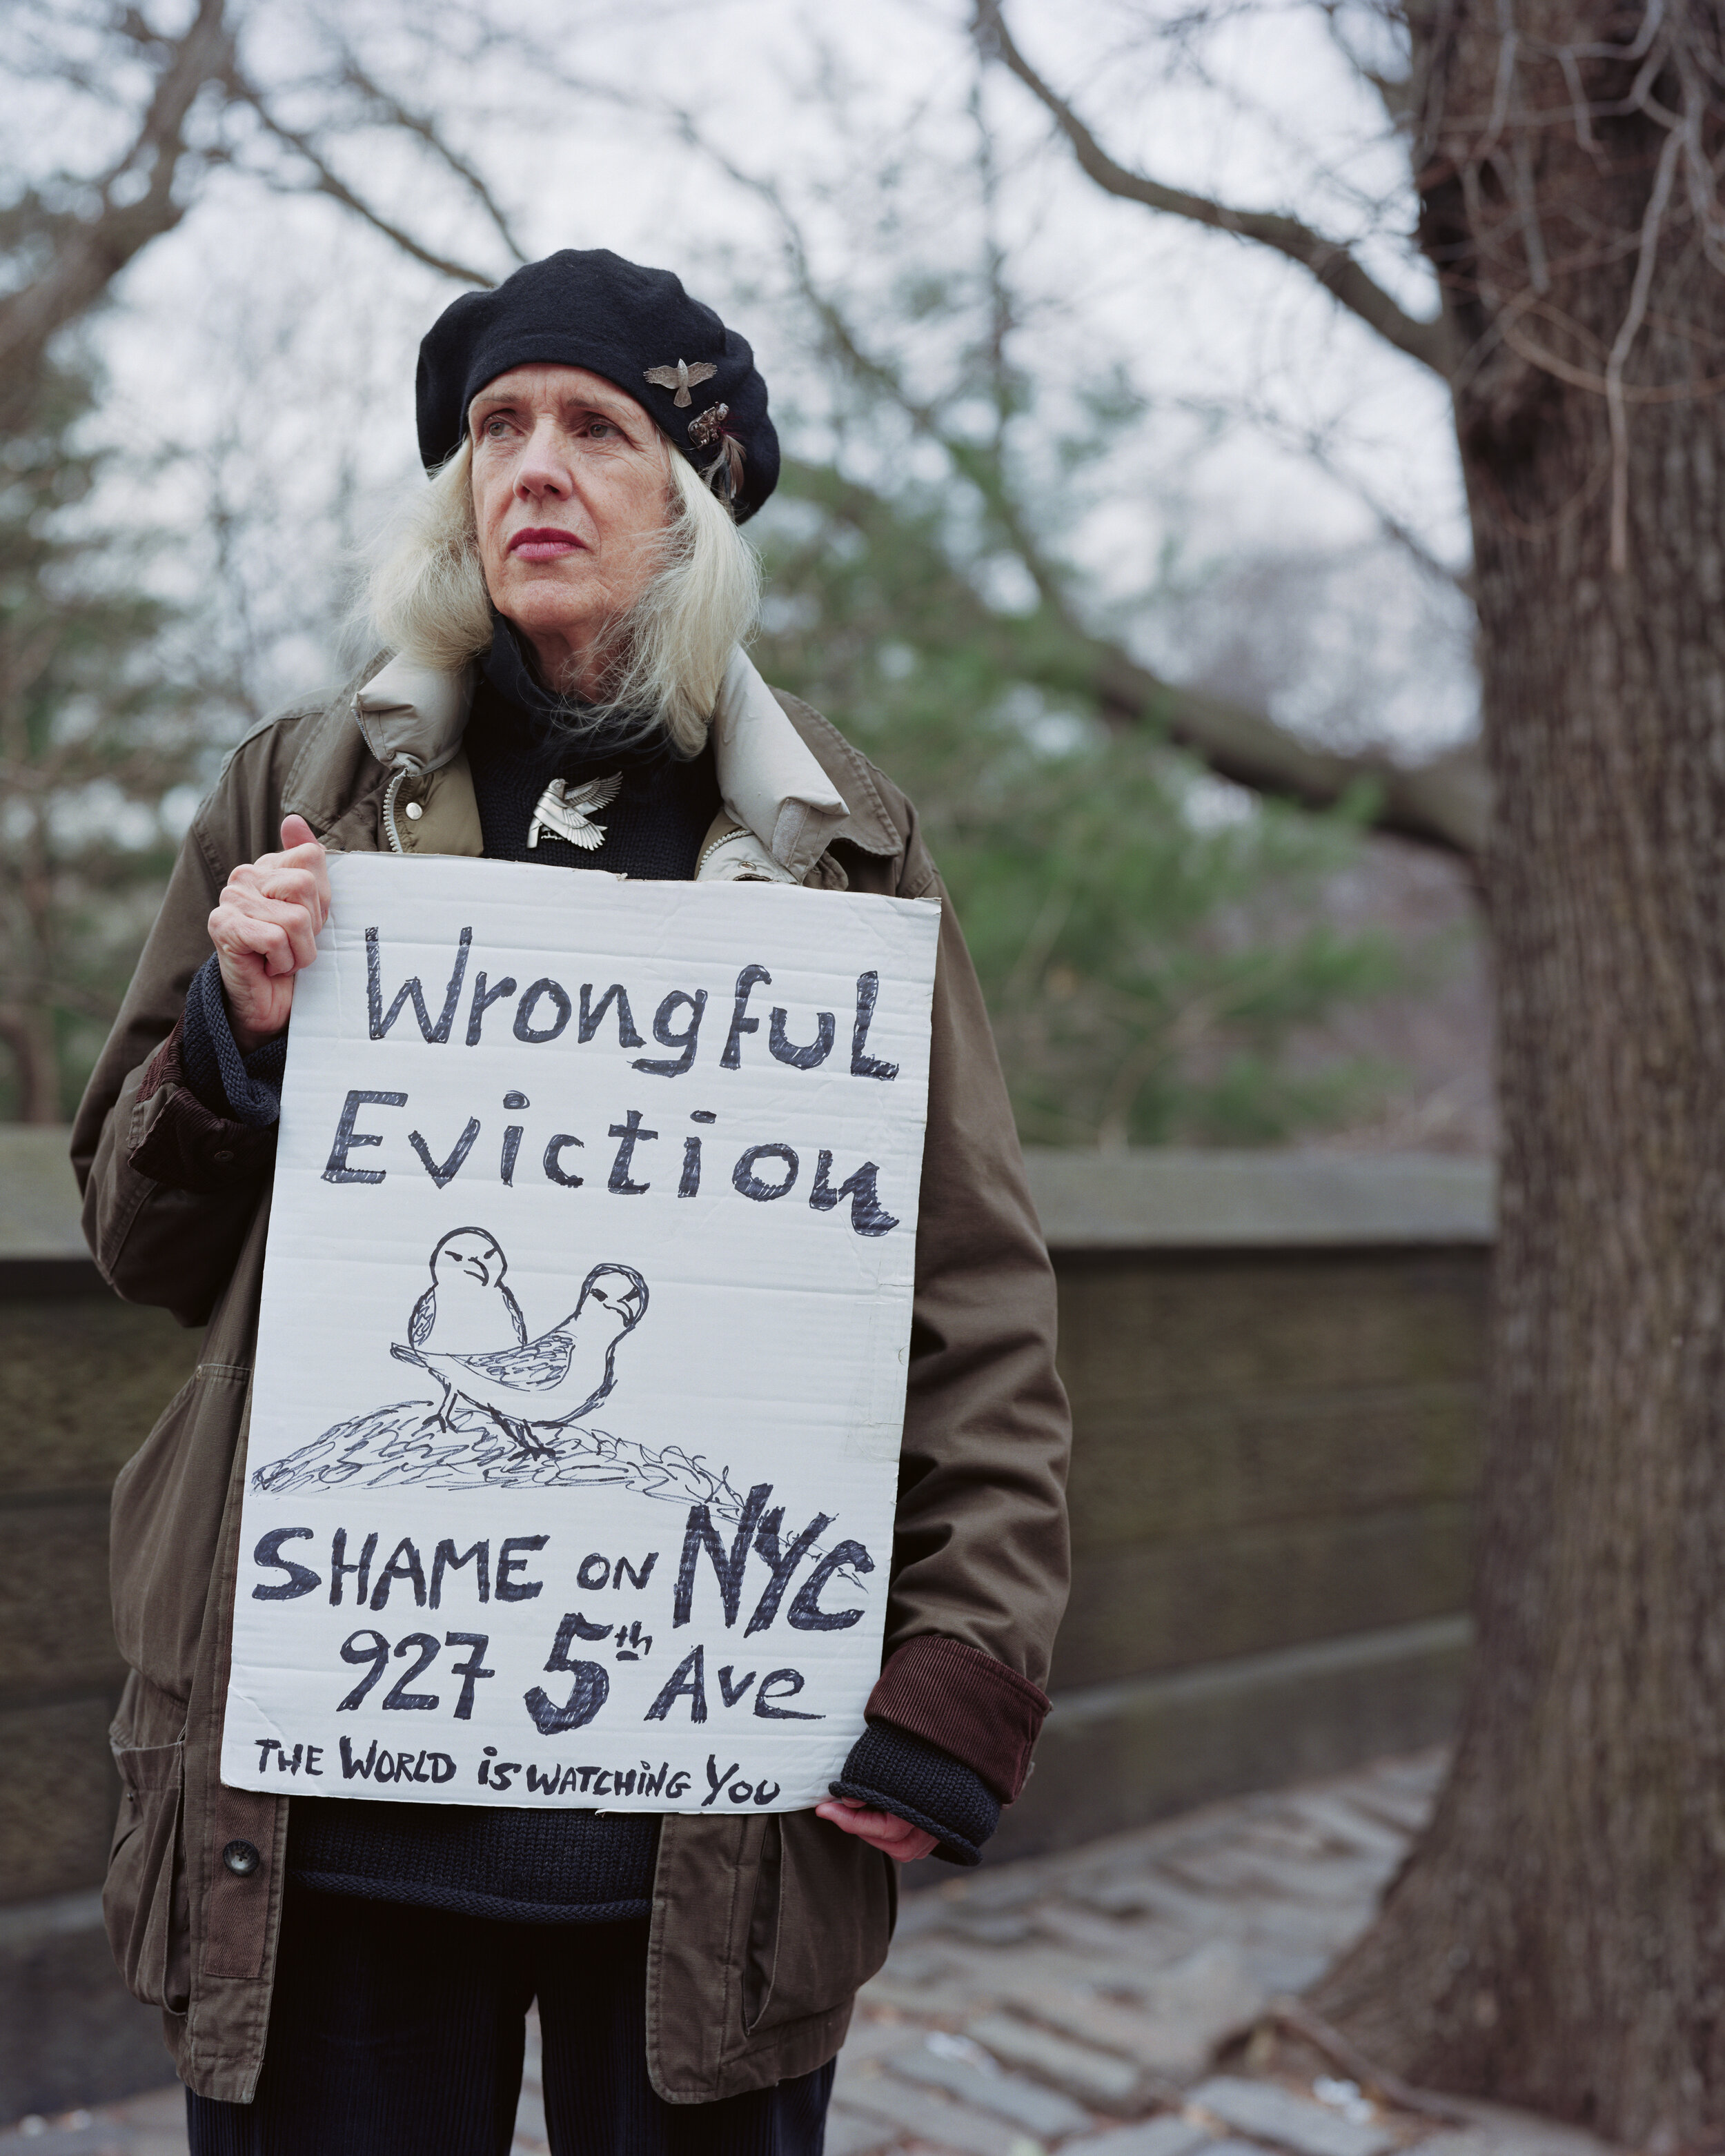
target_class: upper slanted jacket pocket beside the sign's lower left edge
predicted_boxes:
[108,1363,253,1699]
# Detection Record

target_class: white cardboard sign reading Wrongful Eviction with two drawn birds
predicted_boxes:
[222,856,940,1811]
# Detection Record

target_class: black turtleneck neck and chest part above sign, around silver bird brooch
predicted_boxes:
[464,619,718,882]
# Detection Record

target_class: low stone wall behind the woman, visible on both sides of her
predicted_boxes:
[0,1130,1490,2119]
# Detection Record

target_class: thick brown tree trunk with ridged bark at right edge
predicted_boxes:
[1313,12,1725,2148]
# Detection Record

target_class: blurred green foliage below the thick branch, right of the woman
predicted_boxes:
[757,464,1406,1145]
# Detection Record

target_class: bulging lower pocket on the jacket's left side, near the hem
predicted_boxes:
[101,1677,192,2014]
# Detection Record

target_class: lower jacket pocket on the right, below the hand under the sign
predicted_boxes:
[742,1811,899,2039]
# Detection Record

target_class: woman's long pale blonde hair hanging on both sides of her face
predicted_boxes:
[360,442,761,757]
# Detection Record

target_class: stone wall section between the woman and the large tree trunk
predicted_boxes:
[992,1154,1492,1859]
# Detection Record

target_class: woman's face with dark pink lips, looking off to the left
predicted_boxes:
[468,364,671,692]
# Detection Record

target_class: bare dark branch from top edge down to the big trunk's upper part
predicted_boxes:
[972,0,1455,382]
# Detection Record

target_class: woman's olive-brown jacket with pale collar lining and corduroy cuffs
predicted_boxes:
[73,653,1070,2104]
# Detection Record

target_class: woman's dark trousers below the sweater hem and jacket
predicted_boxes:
[186,1882,832,2156]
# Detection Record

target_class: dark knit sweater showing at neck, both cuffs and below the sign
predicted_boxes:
[181,621,1000,1923]
